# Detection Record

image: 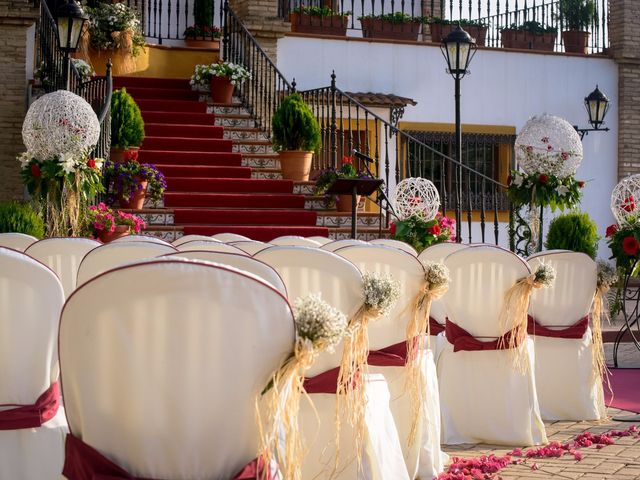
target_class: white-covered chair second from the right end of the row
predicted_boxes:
[436,246,547,446]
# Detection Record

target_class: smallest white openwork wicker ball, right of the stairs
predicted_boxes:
[395,178,440,221]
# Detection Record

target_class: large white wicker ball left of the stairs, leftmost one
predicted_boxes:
[22,90,100,160]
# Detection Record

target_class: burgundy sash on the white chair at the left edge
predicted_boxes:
[0,382,60,430]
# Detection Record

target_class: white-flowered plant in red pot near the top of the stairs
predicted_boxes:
[190,62,251,105]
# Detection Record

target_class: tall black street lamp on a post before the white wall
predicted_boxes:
[440,23,476,242]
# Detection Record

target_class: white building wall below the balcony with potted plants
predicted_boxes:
[278,37,618,258]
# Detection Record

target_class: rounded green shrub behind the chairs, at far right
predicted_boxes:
[545,212,599,259]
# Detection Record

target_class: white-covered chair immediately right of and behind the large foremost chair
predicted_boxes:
[255,246,409,480]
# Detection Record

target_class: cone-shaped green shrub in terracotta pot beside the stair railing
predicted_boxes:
[272,93,321,152]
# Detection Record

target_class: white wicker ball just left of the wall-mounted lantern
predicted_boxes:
[515,114,583,178]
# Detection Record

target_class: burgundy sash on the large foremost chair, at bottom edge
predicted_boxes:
[62,434,275,480]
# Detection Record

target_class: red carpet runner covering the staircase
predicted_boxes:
[114,77,329,241]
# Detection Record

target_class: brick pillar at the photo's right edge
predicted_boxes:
[609,0,640,178]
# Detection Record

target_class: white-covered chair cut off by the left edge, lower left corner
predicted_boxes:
[0,247,68,480]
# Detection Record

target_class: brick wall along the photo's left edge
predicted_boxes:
[0,0,39,201]
